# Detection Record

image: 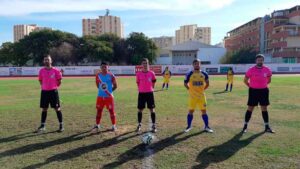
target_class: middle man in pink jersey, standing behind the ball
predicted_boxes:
[136,58,157,133]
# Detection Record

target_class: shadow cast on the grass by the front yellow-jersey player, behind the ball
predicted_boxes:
[102,131,203,169]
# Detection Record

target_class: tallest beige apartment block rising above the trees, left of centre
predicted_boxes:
[82,14,124,38]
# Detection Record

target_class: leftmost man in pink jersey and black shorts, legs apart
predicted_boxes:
[37,55,64,132]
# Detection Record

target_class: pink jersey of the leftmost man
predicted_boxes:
[39,67,62,90]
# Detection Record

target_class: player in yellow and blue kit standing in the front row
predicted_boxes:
[184,59,214,133]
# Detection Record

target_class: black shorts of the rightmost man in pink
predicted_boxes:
[248,88,270,106]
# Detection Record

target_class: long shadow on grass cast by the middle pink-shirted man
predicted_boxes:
[24,131,138,169]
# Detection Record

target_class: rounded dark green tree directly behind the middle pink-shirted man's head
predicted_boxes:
[126,32,157,65]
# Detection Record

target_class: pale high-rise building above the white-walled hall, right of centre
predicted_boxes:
[175,24,211,44]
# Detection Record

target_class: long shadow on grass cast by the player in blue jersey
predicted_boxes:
[0,130,93,159]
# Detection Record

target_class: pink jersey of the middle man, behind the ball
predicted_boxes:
[136,71,156,93]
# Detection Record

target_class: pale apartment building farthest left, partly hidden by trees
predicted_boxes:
[14,24,52,42]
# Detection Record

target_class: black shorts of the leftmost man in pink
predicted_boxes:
[40,90,60,108]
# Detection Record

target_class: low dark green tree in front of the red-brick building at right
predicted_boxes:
[220,48,257,64]
